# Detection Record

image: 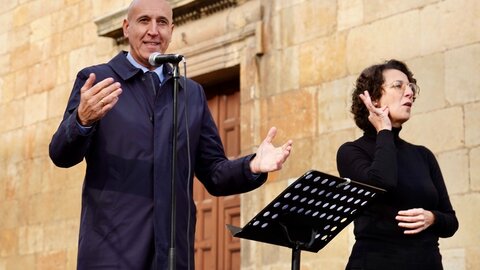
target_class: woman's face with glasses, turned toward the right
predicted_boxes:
[377,69,416,127]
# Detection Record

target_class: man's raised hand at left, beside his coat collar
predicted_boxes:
[77,73,122,126]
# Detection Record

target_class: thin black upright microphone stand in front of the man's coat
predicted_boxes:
[168,62,180,270]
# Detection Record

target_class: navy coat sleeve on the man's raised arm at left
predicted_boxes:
[49,70,95,168]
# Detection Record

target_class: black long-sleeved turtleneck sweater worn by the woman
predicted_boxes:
[337,129,458,270]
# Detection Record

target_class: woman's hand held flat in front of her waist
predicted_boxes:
[395,208,435,234]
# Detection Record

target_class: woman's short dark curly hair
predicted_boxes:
[350,59,417,131]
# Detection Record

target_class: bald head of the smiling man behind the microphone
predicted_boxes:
[123,0,174,69]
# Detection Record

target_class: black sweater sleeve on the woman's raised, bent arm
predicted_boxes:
[337,130,398,190]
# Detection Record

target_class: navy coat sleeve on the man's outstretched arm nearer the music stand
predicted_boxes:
[195,86,267,196]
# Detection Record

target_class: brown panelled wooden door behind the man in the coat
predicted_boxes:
[193,81,240,270]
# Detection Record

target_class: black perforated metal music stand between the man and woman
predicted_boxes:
[227,170,385,270]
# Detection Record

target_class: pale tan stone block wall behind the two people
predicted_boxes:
[0,0,480,270]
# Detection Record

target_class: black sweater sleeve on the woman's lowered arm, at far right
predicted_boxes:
[424,148,458,237]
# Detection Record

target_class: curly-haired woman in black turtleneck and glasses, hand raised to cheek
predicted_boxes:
[337,60,458,270]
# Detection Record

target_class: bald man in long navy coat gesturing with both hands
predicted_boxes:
[50,0,292,270]
